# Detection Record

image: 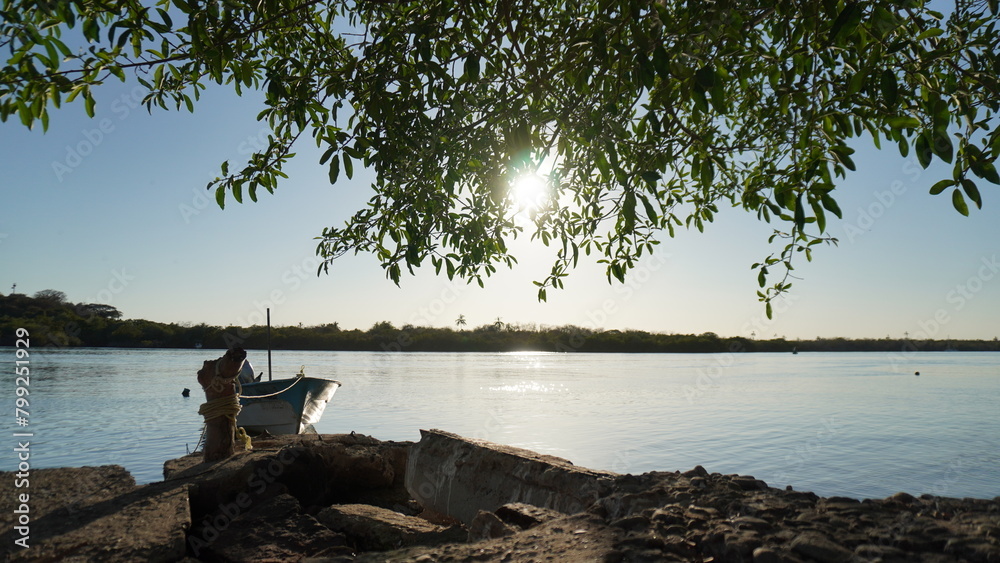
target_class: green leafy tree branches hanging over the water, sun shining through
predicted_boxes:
[0,0,1000,312]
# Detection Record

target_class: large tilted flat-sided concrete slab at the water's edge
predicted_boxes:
[406,430,615,524]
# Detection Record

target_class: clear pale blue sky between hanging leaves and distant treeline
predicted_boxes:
[0,74,1000,339]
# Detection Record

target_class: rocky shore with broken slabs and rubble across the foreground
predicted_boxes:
[0,430,1000,563]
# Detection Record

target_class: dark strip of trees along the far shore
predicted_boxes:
[0,290,1000,353]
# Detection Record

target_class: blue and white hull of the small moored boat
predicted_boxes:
[236,377,340,435]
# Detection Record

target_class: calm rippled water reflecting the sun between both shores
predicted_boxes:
[0,348,1000,498]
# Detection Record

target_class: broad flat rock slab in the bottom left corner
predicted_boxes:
[0,465,191,561]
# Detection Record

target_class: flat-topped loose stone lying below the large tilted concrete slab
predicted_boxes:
[316,504,466,551]
